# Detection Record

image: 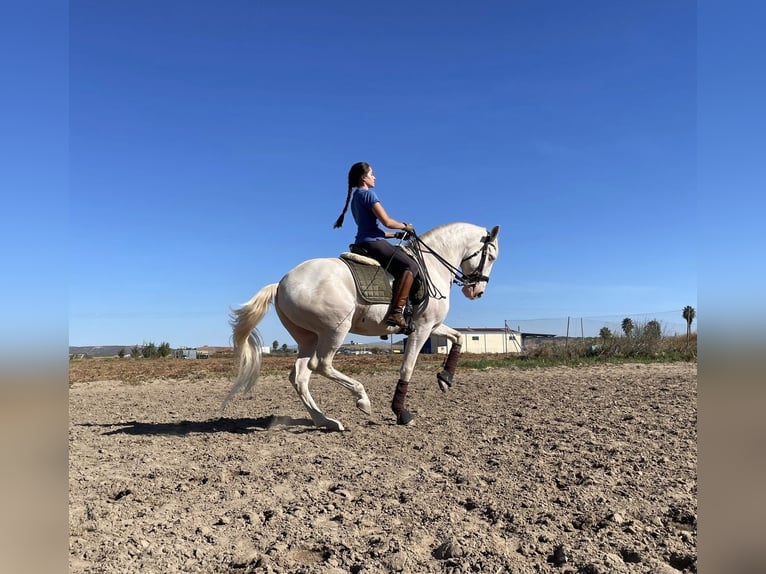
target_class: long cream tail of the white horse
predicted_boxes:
[222,283,278,409]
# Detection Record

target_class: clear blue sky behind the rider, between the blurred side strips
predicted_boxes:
[65,0,697,346]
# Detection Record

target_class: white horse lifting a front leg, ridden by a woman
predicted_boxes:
[224,223,499,430]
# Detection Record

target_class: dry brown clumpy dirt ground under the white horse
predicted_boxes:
[69,356,697,574]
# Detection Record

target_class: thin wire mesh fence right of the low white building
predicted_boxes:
[505,309,696,338]
